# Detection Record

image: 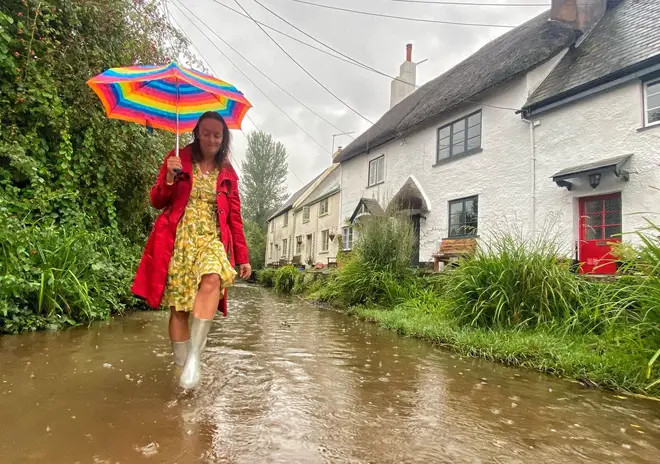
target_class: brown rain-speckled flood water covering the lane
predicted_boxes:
[0,286,660,464]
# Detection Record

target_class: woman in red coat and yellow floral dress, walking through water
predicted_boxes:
[132,112,251,388]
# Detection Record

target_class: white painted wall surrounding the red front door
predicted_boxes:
[534,81,660,252]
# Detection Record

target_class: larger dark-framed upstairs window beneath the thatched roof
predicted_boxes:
[436,110,481,163]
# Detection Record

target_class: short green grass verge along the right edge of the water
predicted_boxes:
[347,307,660,396]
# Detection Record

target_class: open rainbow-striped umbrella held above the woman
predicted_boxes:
[87,62,252,156]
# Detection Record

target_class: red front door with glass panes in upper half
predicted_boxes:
[578,193,621,274]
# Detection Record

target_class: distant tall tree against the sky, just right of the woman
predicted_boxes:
[241,131,287,232]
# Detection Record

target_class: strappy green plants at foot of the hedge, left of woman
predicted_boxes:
[0,212,140,333]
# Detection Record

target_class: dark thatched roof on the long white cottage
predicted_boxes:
[335,11,579,162]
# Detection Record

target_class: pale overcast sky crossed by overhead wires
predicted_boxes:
[168,0,550,193]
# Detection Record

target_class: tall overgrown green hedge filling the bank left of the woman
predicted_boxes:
[0,0,200,333]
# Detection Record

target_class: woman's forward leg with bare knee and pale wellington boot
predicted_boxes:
[179,274,220,388]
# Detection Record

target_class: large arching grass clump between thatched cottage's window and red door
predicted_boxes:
[447,233,580,327]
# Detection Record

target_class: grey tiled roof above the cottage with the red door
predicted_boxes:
[525,0,660,109]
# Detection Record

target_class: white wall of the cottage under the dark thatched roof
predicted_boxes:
[342,75,536,262]
